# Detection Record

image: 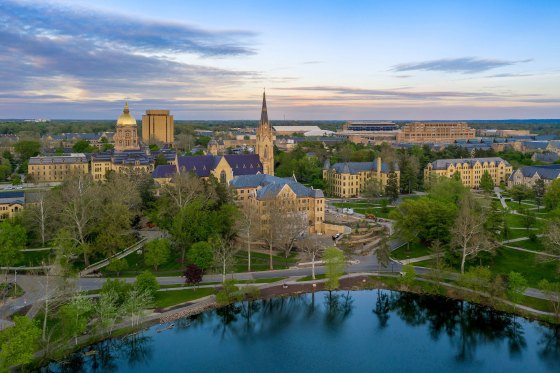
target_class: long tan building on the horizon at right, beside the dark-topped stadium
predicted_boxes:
[397,122,476,143]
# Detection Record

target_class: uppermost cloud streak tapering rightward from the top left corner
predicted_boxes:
[0,0,255,56]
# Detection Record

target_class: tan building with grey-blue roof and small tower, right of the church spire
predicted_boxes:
[323,158,400,198]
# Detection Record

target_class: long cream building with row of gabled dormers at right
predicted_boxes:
[424,157,513,188]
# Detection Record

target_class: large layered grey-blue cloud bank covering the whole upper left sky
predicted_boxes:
[0,1,260,102]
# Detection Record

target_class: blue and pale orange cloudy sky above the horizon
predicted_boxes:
[0,0,560,120]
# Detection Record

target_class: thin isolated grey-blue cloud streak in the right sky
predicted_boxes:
[391,57,531,74]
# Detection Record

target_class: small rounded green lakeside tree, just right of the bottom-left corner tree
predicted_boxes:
[59,294,92,345]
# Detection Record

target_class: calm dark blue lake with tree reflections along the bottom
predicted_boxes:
[49,290,560,373]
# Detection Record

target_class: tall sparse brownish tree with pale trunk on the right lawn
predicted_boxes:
[451,193,494,273]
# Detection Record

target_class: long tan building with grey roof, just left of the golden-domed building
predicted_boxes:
[27,153,89,183]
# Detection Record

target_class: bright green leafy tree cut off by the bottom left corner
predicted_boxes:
[0,316,41,372]
